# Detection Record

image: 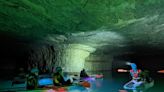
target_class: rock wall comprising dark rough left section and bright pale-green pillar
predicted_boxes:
[27,44,95,72]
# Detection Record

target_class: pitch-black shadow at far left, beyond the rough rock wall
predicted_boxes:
[0,32,41,78]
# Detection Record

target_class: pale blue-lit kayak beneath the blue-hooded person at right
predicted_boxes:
[124,79,154,90]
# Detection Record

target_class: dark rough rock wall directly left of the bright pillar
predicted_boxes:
[27,45,56,71]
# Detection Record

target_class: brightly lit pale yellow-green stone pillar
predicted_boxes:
[57,44,96,72]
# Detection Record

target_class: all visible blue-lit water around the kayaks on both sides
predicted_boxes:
[0,72,164,92]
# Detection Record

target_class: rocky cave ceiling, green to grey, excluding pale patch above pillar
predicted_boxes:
[0,0,164,49]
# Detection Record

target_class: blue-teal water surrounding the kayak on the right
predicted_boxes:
[86,72,164,92]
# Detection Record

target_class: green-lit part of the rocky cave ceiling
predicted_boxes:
[0,0,164,37]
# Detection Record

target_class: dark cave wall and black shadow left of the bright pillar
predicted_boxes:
[0,33,58,78]
